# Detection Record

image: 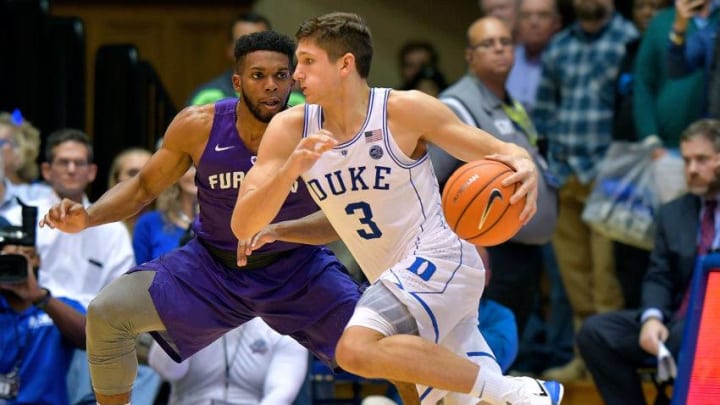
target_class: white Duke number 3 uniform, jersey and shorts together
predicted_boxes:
[302,88,492,404]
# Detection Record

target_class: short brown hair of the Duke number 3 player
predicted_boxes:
[295,12,373,78]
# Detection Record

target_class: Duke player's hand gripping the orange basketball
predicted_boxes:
[485,154,538,225]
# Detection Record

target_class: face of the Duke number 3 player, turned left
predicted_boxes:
[293,39,342,103]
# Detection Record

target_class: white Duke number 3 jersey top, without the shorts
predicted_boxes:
[302,88,472,281]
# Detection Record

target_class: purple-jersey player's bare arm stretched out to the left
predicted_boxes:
[40,106,207,233]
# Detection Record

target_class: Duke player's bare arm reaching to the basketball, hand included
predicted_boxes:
[388,91,538,223]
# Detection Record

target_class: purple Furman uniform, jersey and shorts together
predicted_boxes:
[130,99,360,366]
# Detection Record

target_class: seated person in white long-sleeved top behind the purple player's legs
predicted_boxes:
[150,318,308,405]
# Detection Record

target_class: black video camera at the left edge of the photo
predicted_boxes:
[0,198,38,284]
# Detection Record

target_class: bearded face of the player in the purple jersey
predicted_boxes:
[233,51,293,122]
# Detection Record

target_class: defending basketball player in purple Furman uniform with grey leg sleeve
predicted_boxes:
[41,31,372,405]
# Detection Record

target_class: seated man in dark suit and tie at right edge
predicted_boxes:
[577,120,720,404]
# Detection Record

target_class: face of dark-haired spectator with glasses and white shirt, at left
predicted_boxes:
[42,141,97,201]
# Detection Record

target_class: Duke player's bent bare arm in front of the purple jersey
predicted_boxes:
[231,106,335,241]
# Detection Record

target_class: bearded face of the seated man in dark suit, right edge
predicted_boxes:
[680,136,720,196]
